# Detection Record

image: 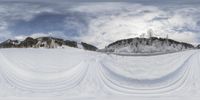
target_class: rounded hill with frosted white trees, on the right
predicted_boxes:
[103,37,195,53]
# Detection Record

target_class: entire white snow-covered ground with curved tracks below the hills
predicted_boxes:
[0,47,200,100]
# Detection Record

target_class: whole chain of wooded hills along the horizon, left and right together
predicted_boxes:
[0,37,200,54]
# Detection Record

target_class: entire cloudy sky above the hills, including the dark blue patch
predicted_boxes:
[0,0,200,48]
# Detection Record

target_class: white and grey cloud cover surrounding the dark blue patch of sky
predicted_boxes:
[0,2,200,48]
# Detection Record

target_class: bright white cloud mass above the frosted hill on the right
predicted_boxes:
[70,3,200,48]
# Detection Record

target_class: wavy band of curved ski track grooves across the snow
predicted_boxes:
[0,51,200,96]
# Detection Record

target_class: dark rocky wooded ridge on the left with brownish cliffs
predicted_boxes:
[0,37,97,51]
